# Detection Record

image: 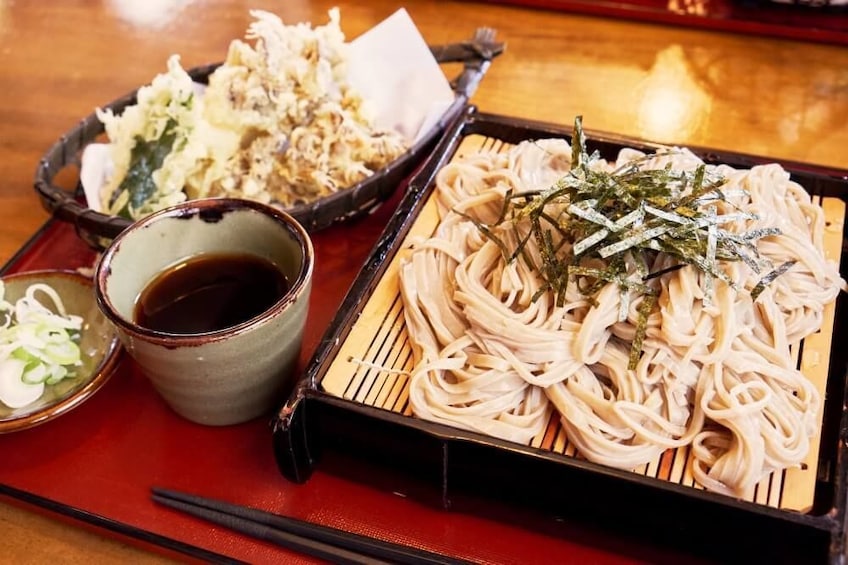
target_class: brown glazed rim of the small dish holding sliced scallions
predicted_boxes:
[0,269,123,434]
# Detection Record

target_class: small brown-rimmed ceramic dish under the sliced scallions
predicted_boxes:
[0,270,121,433]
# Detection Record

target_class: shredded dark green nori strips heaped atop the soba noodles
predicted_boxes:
[466,116,791,368]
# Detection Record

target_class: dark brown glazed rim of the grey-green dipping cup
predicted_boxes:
[94,197,315,347]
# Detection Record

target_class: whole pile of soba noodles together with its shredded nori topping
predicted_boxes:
[400,119,845,496]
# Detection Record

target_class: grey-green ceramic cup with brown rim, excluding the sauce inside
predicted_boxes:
[94,198,314,426]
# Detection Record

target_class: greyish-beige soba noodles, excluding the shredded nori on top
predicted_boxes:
[400,134,845,496]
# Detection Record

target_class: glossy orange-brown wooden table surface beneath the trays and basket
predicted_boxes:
[0,0,848,563]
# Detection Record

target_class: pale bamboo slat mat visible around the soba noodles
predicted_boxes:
[321,135,846,512]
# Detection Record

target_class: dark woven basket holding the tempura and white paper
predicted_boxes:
[35,33,504,249]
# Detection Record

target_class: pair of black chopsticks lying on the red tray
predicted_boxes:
[152,487,470,565]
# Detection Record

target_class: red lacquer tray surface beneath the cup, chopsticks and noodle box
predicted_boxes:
[0,190,691,564]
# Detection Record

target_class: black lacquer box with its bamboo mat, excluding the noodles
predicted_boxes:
[273,107,848,563]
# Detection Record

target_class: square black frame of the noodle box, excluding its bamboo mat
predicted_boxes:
[272,106,848,564]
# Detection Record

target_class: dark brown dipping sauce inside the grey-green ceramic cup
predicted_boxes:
[135,253,289,335]
